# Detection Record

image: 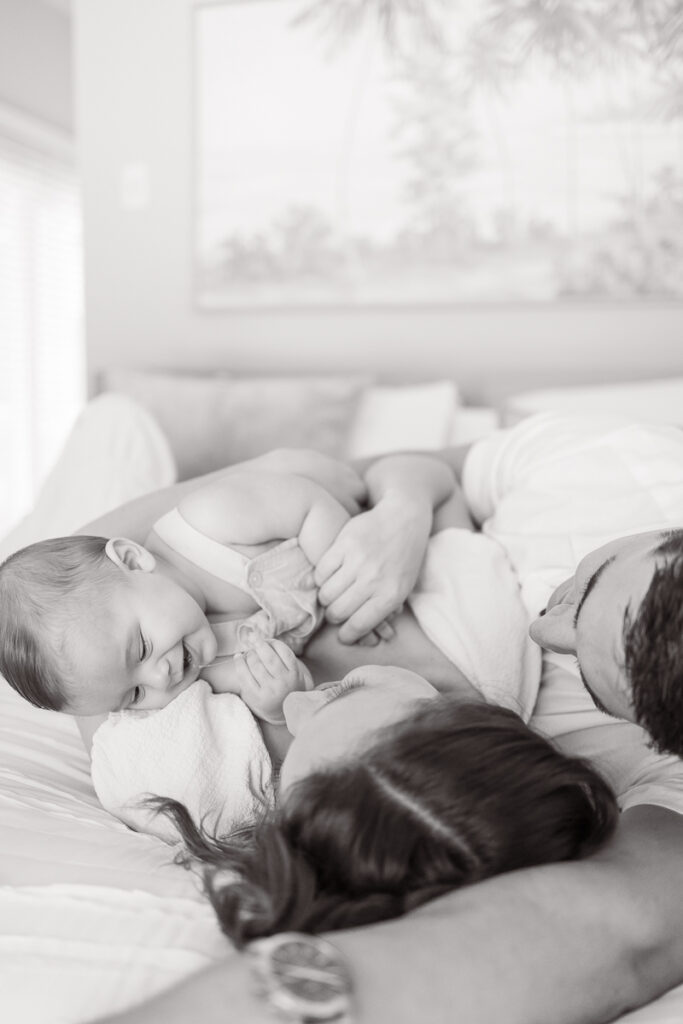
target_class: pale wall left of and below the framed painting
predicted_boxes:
[75,0,683,399]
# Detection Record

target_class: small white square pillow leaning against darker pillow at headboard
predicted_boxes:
[346,380,459,459]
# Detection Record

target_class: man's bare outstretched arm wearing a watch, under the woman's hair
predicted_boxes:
[93,807,683,1024]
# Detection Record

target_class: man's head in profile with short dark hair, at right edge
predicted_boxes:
[530,529,683,756]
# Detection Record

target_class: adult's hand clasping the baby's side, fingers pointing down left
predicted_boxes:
[315,495,432,644]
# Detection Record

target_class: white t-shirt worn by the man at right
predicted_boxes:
[463,414,683,813]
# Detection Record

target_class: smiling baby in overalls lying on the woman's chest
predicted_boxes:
[0,469,374,723]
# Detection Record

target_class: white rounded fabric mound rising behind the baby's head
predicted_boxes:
[0,394,176,558]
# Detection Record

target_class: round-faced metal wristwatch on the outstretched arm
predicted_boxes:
[246,932,353,1024]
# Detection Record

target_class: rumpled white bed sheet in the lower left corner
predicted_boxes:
[0,681,229,1024]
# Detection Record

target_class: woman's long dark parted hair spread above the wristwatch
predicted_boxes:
[154,696,617,946]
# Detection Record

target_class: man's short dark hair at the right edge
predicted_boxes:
[624,529,683,757]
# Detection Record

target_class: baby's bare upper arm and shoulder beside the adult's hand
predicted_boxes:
[178,471,349,565]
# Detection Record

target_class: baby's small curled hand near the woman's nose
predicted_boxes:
[233,640,313,725]
